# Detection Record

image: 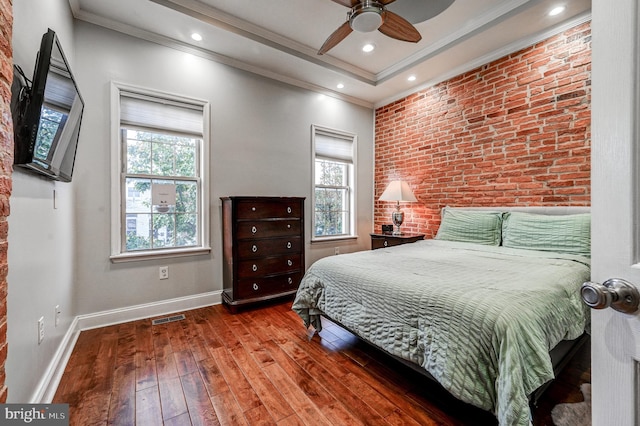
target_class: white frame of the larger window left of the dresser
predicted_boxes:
[110,82,211,263]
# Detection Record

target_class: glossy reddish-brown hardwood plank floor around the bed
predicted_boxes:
[53,301,590,426]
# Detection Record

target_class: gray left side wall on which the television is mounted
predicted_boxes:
[5,0,76,402]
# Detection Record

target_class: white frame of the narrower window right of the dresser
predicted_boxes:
[310,124,358,242]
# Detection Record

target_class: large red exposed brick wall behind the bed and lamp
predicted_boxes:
[374,23,591,237]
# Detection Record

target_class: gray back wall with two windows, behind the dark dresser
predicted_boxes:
[74,22,374,314]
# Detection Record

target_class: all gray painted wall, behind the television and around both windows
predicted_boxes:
[6,0,374,402]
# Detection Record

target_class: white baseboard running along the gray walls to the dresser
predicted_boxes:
[31,291,222,404]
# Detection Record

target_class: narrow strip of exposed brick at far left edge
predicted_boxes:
[0,0,13,403]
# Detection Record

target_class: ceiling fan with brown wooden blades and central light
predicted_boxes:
[318,0,422,55]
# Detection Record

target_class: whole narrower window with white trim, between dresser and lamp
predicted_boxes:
[312,125,356,240]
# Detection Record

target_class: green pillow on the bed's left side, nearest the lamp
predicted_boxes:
[435,207,502,246]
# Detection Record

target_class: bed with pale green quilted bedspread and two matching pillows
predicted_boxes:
[292,208,590,425]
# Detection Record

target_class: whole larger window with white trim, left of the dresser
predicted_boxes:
[111,83,210,262]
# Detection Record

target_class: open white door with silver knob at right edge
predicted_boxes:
[591,0,640,426]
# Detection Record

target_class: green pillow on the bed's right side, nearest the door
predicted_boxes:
[502,212,591,256]
